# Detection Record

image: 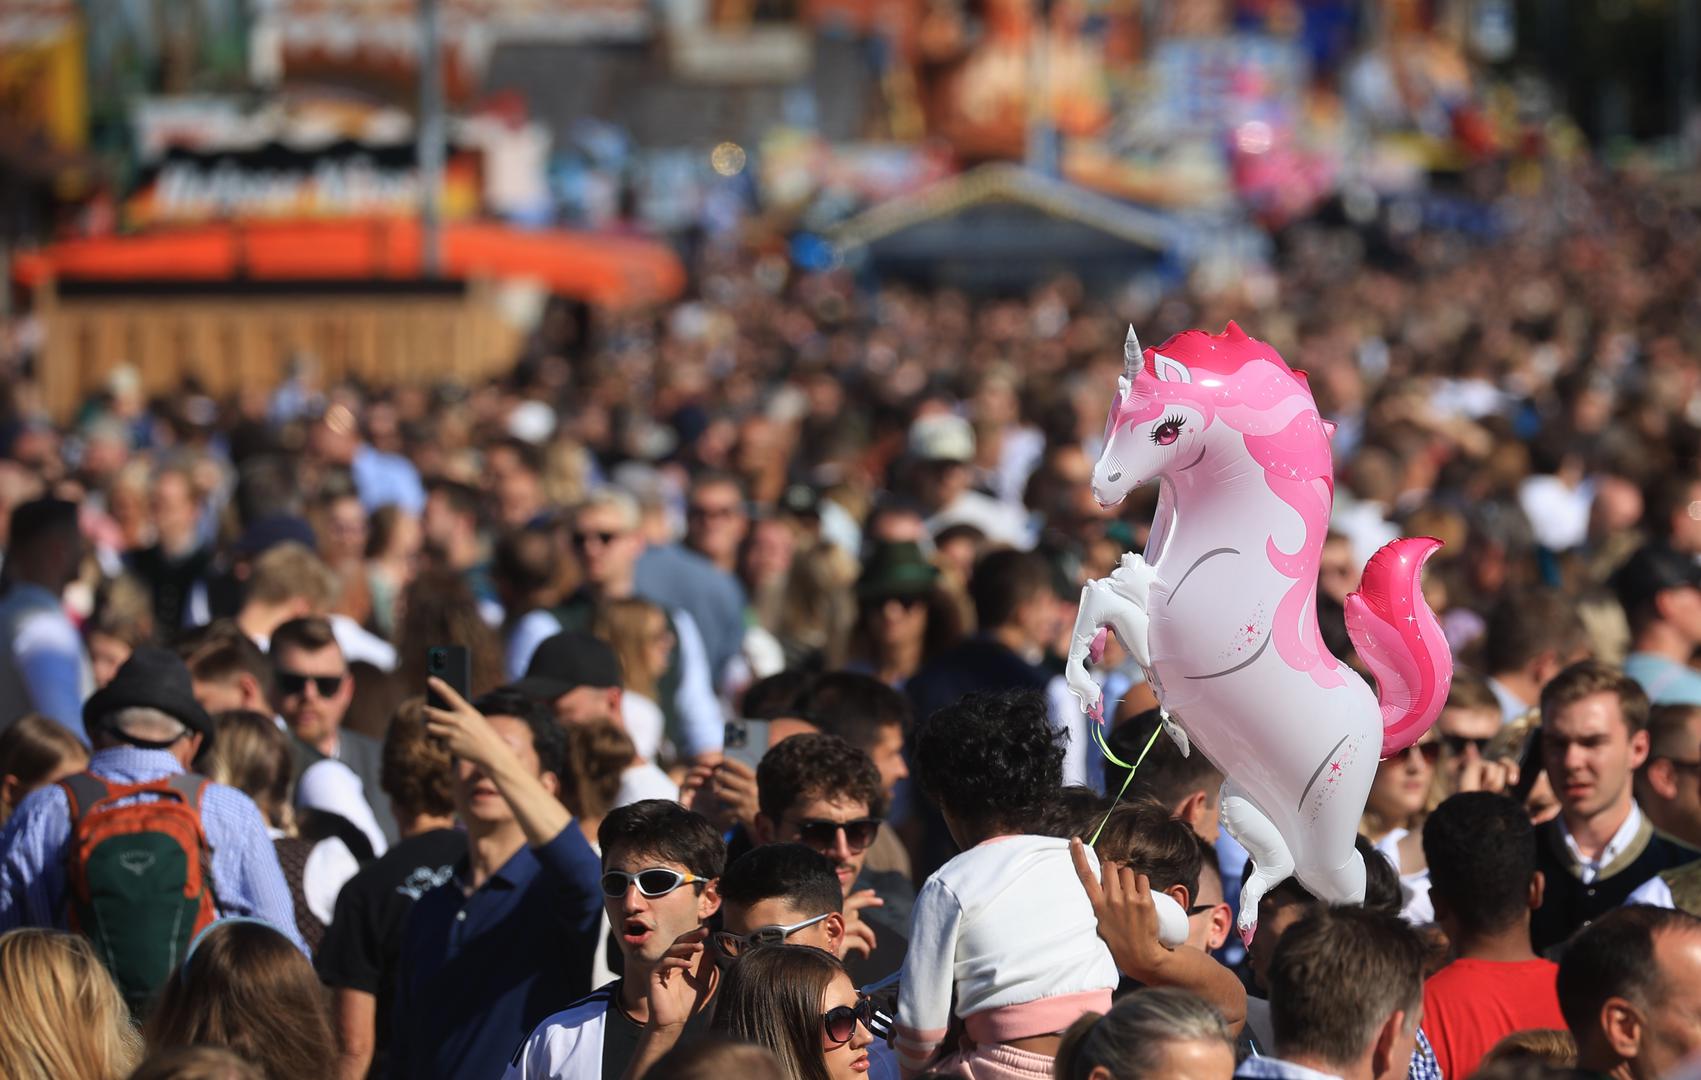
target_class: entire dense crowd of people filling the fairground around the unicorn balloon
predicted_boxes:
[0,167,1701,1080]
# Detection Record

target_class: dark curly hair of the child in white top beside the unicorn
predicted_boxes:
[915,691,1068,832]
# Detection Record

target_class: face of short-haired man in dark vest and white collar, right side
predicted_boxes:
[1541,691,1648,821]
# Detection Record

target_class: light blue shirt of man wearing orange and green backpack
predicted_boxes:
[0,747,306,951]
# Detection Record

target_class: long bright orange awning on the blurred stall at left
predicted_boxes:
[14,219,686,308]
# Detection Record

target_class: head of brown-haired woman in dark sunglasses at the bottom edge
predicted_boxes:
[714,946,874,1080]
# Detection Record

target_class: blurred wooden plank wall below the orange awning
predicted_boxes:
[36,282,521,422]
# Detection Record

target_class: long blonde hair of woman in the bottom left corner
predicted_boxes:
[0,929,141,1080]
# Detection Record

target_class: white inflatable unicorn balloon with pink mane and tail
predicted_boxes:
[1067,323,1453,941]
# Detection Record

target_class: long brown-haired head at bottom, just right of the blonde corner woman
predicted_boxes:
[143,918,337,1080]
